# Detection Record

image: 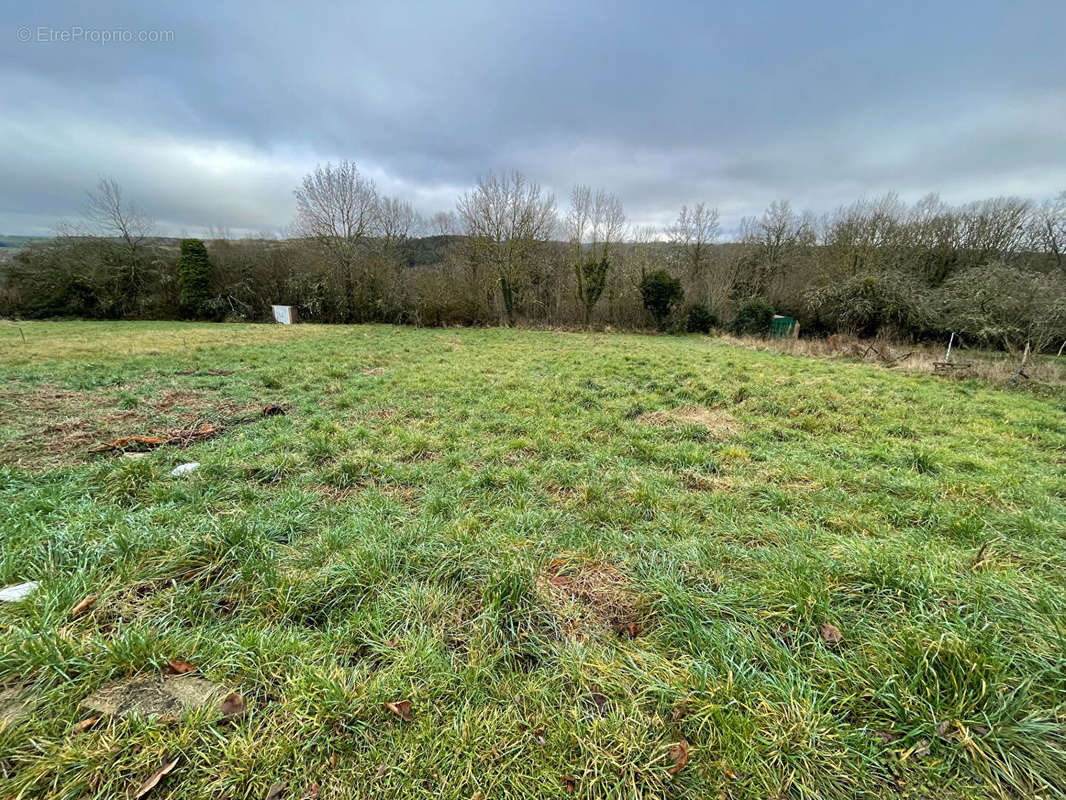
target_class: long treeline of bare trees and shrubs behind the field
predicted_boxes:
[0,169,1066,351]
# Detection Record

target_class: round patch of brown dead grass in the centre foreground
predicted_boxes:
[537,558,646,639]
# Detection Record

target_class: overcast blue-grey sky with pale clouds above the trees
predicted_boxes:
[0,0,1066,236]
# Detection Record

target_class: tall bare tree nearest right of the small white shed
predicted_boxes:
[294,161,381,321]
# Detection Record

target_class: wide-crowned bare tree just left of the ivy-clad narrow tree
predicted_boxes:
[456,172,556,325]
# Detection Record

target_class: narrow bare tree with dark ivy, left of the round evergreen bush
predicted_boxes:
[566,186,626,324]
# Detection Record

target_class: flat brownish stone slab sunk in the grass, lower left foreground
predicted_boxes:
[82,675,228,719]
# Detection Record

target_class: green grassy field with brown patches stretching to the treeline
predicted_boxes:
[0,323,1066,800]
